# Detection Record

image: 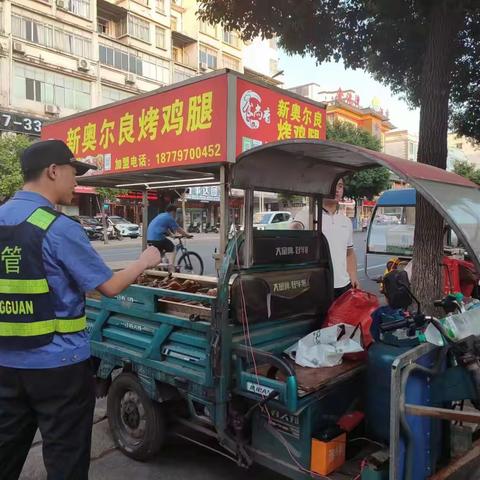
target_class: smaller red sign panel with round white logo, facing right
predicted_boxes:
[236,78,326,155]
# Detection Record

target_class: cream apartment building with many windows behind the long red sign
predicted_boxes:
[0,0,276,135]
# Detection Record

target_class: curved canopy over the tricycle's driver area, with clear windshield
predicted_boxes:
[232,140,480,271]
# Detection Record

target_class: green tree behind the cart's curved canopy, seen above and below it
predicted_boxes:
[327,121,391,202]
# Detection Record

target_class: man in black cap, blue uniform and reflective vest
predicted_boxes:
[0,140,160,480]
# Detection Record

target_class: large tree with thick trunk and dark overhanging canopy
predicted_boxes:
[199,0,480,311]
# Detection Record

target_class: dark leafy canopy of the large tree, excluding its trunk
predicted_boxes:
[199,0,480,140]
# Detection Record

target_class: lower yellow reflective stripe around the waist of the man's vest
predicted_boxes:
[0,316,87,337]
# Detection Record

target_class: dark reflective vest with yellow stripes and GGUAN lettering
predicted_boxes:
[0,207,87,350]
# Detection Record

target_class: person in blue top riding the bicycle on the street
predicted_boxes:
[147,204,193,265]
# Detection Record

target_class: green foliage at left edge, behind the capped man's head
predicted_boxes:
[0,135,32,201]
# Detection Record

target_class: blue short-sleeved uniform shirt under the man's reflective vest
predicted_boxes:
[0,191,112,368]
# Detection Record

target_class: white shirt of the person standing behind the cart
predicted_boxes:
[322,210,353,288]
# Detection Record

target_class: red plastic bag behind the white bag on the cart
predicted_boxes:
[323,288,380,360]
